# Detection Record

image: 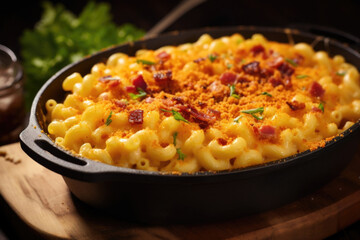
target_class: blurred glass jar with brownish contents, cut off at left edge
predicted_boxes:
[0,45,26,145]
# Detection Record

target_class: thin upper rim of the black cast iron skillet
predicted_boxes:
[23,26,360,181]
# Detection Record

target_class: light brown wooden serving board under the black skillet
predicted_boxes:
[0,143,360,240]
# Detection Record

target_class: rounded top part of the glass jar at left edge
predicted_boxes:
[0,44,23,90]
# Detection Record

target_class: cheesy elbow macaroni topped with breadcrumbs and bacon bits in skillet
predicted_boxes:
[45,34,360,172]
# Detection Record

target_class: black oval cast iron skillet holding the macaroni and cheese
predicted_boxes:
[20,26,360,223]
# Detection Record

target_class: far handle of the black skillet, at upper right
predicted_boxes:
[289,24,360,52]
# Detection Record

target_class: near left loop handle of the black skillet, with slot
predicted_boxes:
[20,123,101,181]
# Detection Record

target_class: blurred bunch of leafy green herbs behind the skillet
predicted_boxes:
[20,1,145,107]
